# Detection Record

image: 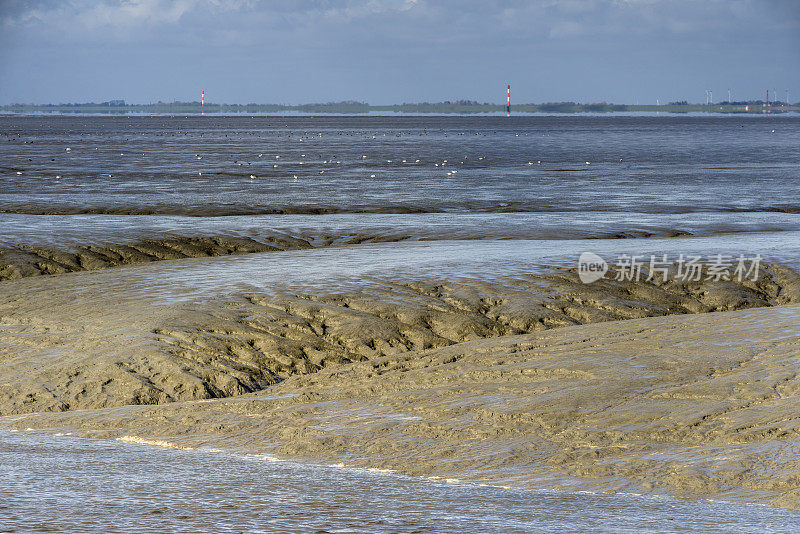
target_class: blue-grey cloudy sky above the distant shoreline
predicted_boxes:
[0,0,800,104]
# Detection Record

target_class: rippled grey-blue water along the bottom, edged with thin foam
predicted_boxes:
[0,430,800,533]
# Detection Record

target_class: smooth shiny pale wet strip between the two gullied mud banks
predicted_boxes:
[26,232,800,303]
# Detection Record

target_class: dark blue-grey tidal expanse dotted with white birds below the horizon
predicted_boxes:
[0,116,800,244]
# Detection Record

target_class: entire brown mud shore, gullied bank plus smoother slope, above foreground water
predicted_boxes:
[0,251,800,507]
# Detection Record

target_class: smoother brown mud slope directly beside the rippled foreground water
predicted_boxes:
[2,306,800,508]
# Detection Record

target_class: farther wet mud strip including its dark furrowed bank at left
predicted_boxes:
[0,211,800,281]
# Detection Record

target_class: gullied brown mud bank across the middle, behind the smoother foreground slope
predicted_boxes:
[0,265,800,414]
